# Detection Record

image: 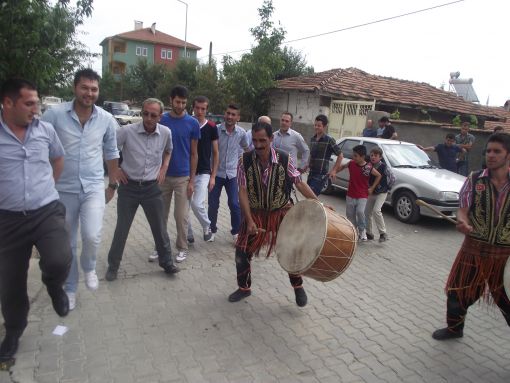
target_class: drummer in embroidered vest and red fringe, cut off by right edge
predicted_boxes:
[432,133,510,340]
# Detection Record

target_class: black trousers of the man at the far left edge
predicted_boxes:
[0,201,72,336]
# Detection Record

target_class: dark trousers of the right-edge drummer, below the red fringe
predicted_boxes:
[446,265,510,331]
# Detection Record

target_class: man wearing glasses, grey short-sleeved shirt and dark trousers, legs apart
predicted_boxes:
[105,98,179,282]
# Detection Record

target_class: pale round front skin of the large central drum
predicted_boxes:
[276,200,328,274]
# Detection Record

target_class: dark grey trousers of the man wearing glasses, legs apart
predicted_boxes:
[108,181,173,270]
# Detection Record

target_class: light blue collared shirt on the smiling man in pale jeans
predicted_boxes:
[42,100,119,193]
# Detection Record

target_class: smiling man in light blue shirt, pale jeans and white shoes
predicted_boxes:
[42,69,119,310]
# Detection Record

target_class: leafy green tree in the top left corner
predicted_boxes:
[0,0,93,93]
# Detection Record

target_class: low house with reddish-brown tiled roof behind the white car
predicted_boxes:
[269,68,510,138]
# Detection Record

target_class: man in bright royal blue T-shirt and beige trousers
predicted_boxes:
[154,85,200,262]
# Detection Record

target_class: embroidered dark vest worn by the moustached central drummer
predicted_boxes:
[243,149,292,211]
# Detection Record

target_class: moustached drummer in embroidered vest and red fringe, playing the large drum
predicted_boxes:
[228,122,317,307]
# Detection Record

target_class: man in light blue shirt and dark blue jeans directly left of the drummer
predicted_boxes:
[207,104,249,243]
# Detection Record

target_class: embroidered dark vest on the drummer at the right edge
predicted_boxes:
[469,172,510,247]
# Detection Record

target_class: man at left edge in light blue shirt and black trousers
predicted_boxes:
[0,79,72,370]
